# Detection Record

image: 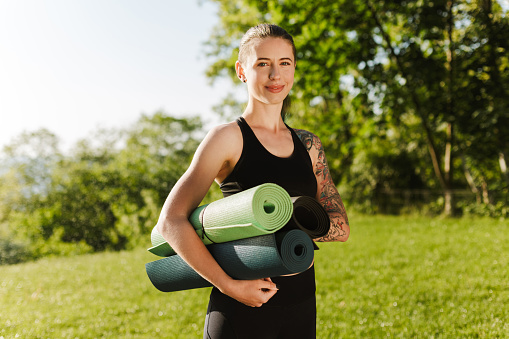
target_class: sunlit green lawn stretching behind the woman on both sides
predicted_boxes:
[0,216,509,338]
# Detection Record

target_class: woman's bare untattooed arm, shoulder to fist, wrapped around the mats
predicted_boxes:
[157,124,277,306]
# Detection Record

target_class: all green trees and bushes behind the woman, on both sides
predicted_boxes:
[0,0,509,263]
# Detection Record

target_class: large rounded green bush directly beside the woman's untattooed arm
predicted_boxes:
[47,112,201,251]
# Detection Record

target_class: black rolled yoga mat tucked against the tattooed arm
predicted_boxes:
[288,196,330,239]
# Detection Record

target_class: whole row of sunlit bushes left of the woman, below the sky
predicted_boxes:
[0,112,201,264]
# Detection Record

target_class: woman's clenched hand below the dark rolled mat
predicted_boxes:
[218,278,278,307]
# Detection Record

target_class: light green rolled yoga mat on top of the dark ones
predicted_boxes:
[148,183,293,257]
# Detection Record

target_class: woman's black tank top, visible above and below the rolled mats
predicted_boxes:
[212,117,317,307]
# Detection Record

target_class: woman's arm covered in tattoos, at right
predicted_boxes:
[295,130,350,242]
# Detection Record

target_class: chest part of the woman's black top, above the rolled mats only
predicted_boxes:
[220,117,317,198]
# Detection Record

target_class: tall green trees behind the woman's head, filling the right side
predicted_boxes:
[203,0,509,214]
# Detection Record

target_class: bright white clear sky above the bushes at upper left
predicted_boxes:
[0,0,240,148]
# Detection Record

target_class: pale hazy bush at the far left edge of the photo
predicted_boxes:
[0,129,62,264]
